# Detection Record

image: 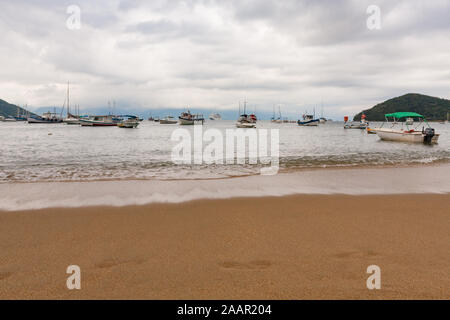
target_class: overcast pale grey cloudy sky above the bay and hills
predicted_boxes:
[0,0,450,116]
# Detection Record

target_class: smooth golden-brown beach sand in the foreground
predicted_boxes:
[0,194,450,299]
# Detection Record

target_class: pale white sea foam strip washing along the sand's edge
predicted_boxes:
[0,164,450,210]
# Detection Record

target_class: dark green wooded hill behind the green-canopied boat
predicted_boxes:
[353,93,450,121]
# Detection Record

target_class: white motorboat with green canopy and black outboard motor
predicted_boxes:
[376,112,439,144]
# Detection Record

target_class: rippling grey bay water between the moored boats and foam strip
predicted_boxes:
[0,121,450,183]
